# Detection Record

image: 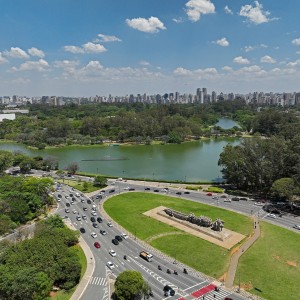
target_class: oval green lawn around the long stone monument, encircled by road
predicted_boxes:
[104,192,252,277]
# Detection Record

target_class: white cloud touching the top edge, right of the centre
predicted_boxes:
[185,0,215,22]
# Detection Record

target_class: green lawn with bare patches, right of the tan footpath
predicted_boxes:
[235,222,300,300]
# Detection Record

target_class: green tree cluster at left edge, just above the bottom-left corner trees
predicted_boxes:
[0,176,52,235]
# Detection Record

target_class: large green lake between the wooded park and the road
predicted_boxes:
[0,138,239,182]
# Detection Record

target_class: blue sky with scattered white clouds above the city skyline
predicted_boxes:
[0,0,300,96]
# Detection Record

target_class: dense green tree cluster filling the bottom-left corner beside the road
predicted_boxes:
[0,216,81,300]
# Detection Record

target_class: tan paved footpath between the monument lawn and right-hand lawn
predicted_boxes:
[225,218,260,288]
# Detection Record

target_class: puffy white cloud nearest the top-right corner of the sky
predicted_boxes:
[239,1,275,24]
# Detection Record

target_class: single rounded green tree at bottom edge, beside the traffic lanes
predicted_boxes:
[115,270,150,300]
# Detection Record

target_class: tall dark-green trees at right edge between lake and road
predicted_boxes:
[219,109,300,199]
